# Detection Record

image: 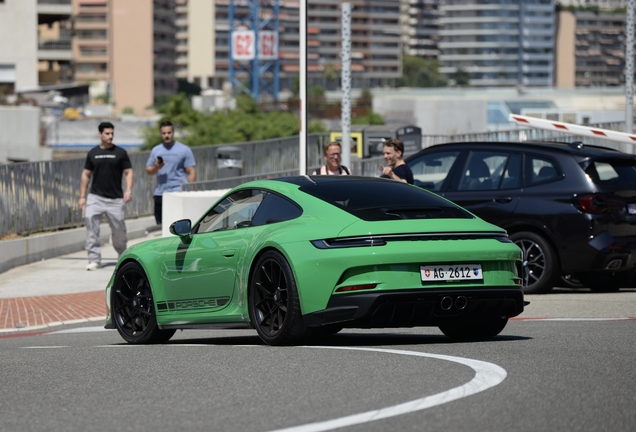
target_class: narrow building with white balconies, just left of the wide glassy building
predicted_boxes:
[401,0,440,59]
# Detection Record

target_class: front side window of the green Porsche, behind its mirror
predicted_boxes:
[192,189,266,233]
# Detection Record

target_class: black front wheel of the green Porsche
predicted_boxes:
[111,262,176,344]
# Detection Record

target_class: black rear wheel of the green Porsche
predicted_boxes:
[249,251,310,345]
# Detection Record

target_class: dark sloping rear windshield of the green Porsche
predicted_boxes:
[300,179,473,221]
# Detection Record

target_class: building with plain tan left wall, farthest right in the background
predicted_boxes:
[556,10,626,88]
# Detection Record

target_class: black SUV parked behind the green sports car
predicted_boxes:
[406,142,636,294]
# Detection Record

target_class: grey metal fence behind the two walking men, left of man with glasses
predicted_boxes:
[0,134,327,237]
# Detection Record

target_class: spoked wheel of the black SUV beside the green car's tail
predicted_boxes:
[510,231,560,294]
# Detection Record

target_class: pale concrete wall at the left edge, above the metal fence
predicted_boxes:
[0,106,53,164]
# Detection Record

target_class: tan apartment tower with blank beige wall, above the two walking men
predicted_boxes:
[72,0,177,113]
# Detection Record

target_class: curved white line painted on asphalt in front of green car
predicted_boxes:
[272,346,507,432]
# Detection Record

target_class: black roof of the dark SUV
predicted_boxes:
[407,141,636,160]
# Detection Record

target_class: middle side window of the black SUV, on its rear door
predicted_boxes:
[458,151,512,190]
